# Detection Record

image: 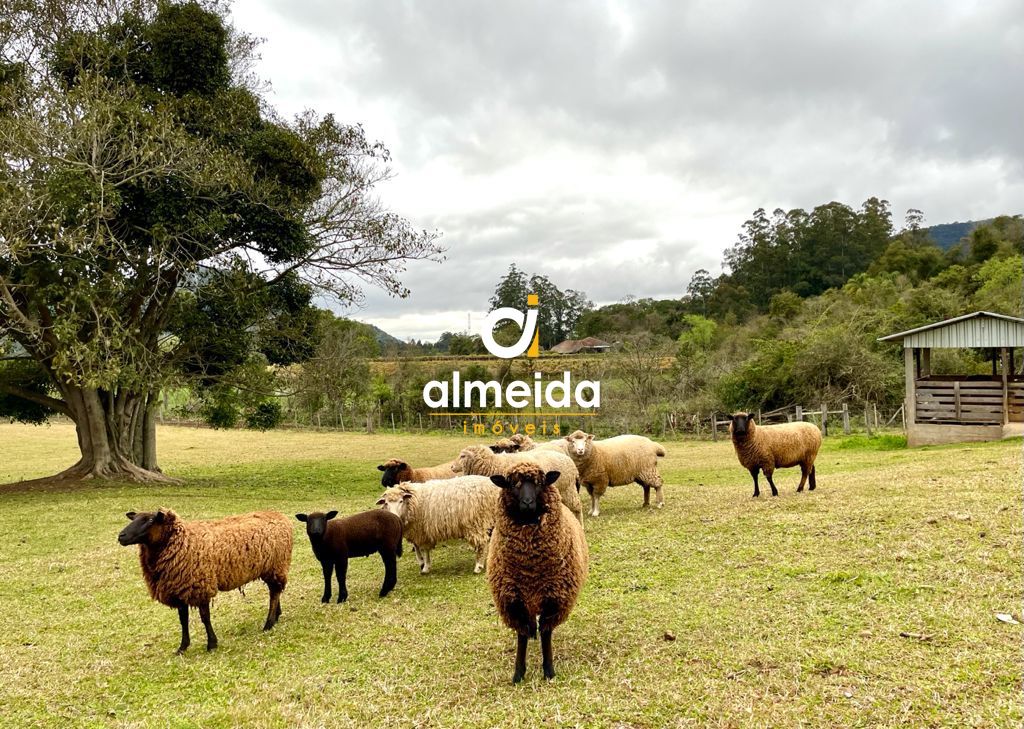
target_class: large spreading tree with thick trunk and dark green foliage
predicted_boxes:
[0,0,440,480]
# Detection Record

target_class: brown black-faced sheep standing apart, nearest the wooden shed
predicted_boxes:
[729,413,821,498]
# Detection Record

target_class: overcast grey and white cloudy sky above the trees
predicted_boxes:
[232,0,1024,339]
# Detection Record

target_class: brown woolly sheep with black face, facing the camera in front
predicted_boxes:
[487,462,589,683]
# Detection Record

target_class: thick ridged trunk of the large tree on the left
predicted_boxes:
[46,387,174,482]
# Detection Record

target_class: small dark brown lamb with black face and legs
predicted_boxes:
[295,509,401,602]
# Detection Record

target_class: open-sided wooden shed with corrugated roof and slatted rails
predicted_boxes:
[879,311,1024,445]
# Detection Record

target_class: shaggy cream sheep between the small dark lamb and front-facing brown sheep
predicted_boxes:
[377,476,498,574]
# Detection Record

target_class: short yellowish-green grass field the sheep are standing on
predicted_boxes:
[0,425,1024,727]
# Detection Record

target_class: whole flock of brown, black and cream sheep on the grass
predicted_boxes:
[118,413,821,683]
